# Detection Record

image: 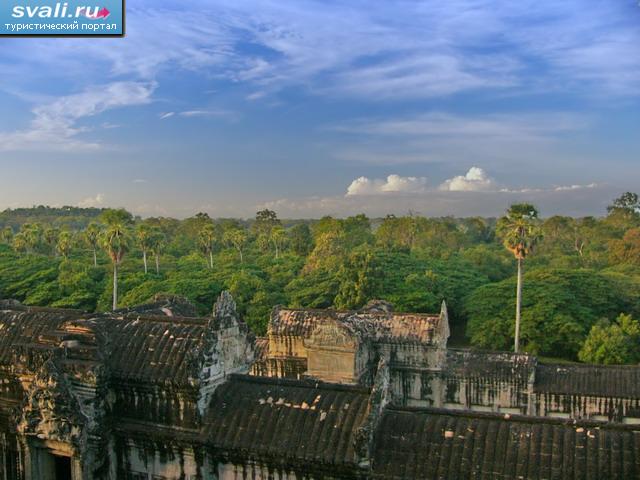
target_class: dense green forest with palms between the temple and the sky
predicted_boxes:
[0,193,640,363]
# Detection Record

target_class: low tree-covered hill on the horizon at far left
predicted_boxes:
[0,205,103,230]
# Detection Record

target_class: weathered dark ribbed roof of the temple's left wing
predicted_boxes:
[0,296,250,386]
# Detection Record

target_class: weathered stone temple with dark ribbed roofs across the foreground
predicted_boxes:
[0,292,640,480]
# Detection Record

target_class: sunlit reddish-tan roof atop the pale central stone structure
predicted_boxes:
[269,308,440,343]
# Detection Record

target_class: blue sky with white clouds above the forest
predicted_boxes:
[0,0,640,218]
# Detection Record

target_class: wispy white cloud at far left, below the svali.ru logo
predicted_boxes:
[0,82,155,151]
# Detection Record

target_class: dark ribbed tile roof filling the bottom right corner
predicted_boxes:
[373,409,640,480]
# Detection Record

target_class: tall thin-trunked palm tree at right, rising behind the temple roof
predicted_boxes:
[496,203,542,353]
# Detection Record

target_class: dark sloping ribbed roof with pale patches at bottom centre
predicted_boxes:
[204,375,369,466]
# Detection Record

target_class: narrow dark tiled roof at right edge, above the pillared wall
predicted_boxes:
[534,364,640,398]
